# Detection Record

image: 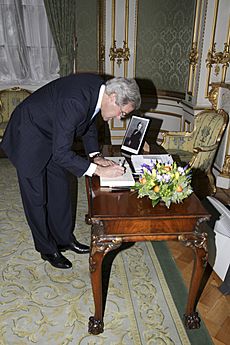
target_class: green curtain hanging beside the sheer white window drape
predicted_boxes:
[44,0,77,76]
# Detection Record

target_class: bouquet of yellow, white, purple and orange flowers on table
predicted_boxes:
[132,162,192,208]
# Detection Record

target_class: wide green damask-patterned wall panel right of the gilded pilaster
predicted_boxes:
[136,0,196,92]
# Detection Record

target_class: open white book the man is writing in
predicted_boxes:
[100,157,135,188]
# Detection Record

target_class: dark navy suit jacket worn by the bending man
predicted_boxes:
[1,74,103,177]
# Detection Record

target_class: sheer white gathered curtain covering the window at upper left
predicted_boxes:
[0,0,59,86]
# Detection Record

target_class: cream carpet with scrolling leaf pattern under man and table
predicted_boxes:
[0,159,211,345]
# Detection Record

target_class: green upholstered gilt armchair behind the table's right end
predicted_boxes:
[162,109,228,194]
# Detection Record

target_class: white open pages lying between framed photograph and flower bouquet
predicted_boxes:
[131,154,173,173]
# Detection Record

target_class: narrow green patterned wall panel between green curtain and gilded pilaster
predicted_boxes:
[76,0,98,72]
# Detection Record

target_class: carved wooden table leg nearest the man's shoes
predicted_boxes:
[88,222,122,335]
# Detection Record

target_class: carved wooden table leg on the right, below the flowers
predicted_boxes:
[178,233,207,329]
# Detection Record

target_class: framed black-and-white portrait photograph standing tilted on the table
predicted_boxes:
[121,115,150,154]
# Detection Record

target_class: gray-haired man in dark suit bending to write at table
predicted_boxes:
[1,74,140,268]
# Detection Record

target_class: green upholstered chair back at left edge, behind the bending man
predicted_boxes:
[0,87,31,141]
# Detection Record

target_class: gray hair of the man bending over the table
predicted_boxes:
[105,77,141,109]
